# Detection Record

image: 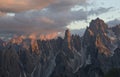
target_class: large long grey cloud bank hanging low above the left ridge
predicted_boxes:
[0,7,86,33]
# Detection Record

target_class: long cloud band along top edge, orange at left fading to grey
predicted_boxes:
[0,0,86,12]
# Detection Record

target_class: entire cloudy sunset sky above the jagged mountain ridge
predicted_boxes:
[0,0,120,33]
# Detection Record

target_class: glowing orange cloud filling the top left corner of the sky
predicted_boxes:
[0,0,54,12]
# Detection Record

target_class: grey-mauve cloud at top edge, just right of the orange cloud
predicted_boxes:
[48,0,87,12]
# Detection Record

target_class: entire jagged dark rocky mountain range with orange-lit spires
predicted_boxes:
[0,18,120,77]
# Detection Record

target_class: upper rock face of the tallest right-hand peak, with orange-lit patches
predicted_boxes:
[84,18,117,55]
